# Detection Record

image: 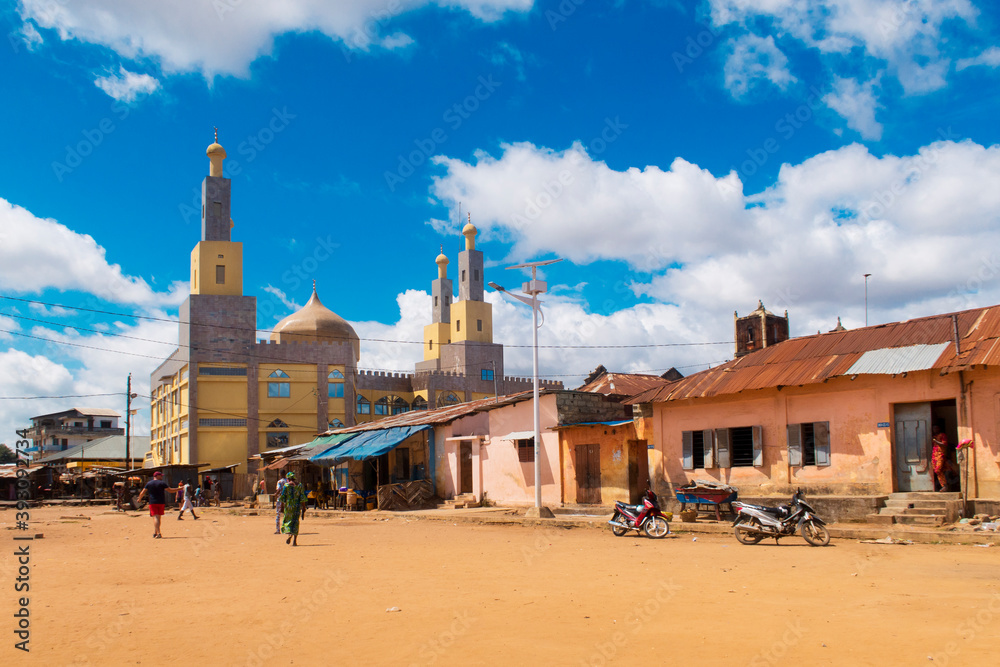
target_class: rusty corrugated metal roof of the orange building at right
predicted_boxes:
[626,306,1000,404]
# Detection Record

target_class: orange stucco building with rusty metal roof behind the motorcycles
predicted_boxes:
[629,306,1000,516]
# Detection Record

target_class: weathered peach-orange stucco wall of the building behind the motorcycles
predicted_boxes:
[637,371,1000,497]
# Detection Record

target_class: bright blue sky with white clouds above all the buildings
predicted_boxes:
[0,0,1000,440]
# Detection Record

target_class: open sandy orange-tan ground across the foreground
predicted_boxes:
[0,508,1000,665]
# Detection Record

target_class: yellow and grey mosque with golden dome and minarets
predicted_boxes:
[147,138,562,472]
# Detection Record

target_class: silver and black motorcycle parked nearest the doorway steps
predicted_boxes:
[733,489,830,547]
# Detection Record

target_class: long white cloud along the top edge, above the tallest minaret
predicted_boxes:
[19,0,532,77]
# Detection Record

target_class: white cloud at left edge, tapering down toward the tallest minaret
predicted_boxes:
[0,198,188,307]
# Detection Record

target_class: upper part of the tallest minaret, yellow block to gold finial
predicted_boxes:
[191,128,243,296]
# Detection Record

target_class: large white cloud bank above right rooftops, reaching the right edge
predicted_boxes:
[434,136,1000,354]
